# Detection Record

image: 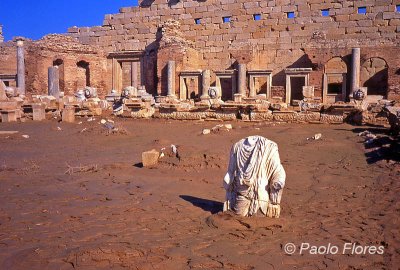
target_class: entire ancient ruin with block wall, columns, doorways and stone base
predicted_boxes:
[0,0,400,123]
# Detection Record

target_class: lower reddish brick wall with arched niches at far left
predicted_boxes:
[0,35,111,96]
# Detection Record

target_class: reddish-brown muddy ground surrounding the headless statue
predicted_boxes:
[0,119,400,269]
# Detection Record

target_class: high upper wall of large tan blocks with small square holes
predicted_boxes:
[69,0,400,55]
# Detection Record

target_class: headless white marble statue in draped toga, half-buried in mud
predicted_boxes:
[224,136,286,218]
